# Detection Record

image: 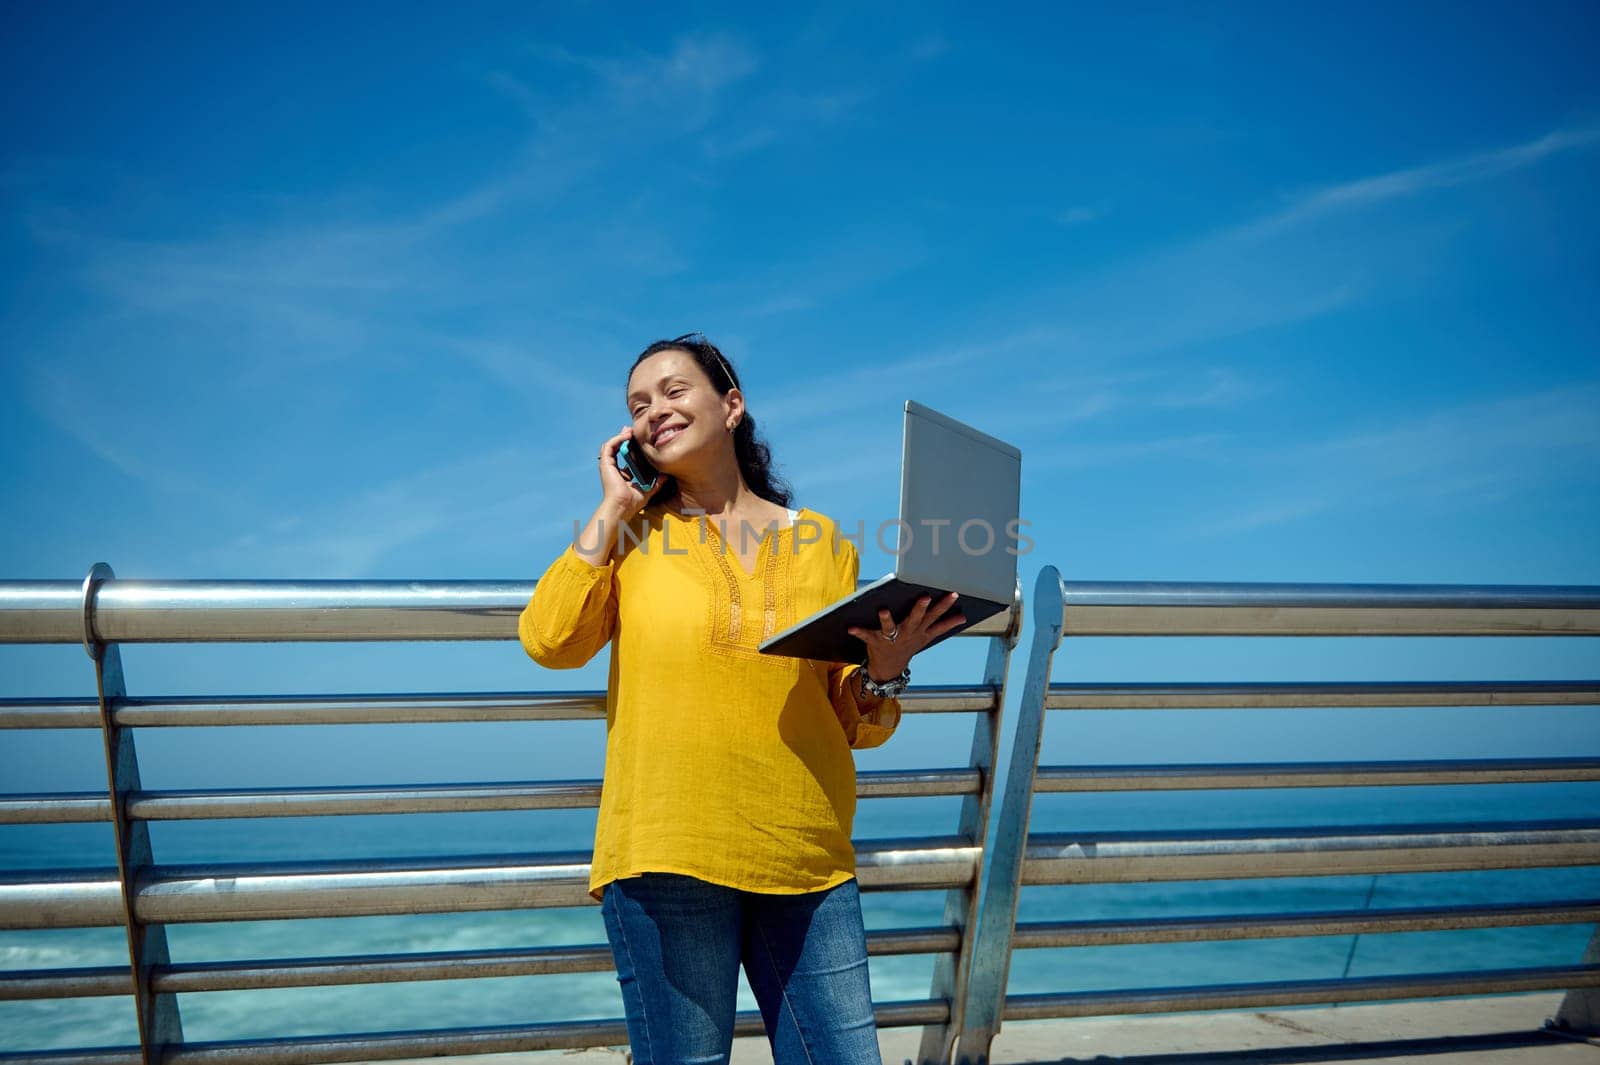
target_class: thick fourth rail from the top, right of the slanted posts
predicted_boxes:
[1021,820,1600,884]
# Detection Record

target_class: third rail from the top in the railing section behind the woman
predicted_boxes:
[0,769,982,825]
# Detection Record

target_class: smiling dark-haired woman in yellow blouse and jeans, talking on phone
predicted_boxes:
[518,334,965,1065]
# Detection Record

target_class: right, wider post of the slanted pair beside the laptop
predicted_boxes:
[954,566,1064,1065]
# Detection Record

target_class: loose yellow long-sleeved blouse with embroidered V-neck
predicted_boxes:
[518,505,901,899]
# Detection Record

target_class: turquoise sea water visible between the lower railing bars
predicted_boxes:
[0,784,1600,1051]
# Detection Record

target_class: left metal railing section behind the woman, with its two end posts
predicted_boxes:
[0,564,1022,1065]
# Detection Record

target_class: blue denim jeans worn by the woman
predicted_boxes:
[600,873,882,1065]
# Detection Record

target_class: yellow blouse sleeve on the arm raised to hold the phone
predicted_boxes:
[517,544,616,670]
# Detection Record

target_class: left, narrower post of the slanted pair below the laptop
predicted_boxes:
[917,584,1024,1065]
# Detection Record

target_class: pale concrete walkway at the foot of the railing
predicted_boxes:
[380,995,1600,1065]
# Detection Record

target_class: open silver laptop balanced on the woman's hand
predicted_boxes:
[760,400,1022,662]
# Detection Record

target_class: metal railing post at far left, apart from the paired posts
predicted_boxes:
[83,563,184,1065]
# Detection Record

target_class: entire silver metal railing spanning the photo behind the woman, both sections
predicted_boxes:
[0,566,1600,1065]
